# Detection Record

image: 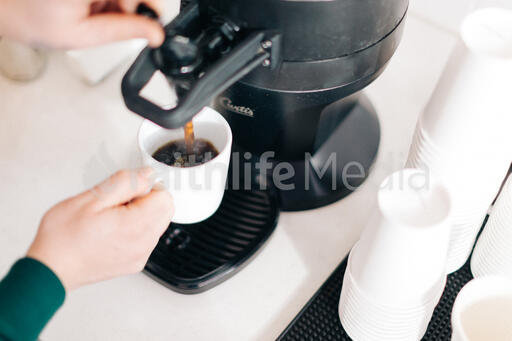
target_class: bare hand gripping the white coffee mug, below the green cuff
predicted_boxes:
[27,169,174,290]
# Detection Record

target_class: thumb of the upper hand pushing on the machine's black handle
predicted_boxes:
[74,13,165,47]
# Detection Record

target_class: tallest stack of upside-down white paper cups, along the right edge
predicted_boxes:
[407,9,512,272]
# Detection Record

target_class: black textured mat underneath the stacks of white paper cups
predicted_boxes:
[278,259,473,341]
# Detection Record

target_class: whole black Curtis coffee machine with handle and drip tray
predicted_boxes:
[122,0,408,294]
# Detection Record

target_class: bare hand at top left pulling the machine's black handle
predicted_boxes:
[0,0,164,49]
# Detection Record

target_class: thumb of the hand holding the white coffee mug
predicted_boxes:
[85,168,153,210]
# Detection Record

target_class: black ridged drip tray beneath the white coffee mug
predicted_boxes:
[145,178,279,294]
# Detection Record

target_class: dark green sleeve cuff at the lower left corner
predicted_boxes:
[0,258,66,341]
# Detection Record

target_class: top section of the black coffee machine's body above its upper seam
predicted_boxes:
[199,0,409,61]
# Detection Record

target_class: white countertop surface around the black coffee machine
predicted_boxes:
[0,7,456,341]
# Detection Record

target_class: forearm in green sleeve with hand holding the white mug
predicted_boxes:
[0,168,173,341]
